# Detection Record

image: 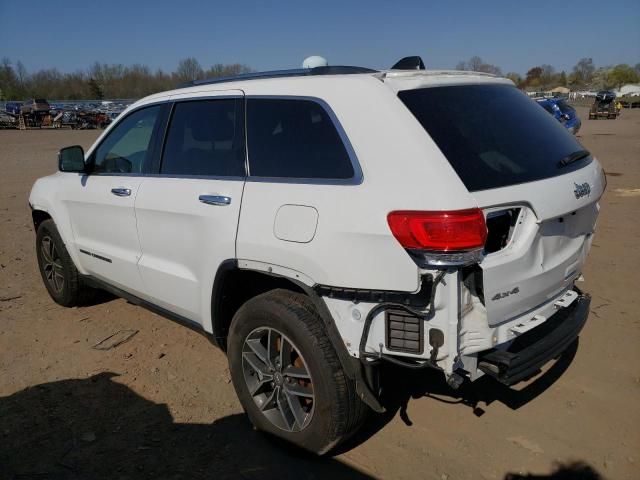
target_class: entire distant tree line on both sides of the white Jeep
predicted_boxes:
[0,56,640,100]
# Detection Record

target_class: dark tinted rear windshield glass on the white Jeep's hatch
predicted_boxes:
[398,85,591,191]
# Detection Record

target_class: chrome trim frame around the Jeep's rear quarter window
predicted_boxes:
[244,95,364,185]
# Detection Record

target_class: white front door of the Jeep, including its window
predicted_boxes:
[63,105,162,295]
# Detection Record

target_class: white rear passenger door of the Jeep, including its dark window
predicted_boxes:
[135,90,245,329]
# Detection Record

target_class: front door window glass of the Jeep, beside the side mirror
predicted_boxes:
[93,105,160,174]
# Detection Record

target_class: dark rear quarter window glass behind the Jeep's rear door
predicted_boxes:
[247,98,354,179]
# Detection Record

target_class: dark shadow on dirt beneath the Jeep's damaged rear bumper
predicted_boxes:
[338,338,579,452]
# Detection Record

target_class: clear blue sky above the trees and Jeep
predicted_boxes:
[0,0,640,73]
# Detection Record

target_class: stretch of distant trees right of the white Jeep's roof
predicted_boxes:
[456,56,640,90]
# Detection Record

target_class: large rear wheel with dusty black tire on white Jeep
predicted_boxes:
[227,290,368,455]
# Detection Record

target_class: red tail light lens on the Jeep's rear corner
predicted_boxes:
[387,208,487,252]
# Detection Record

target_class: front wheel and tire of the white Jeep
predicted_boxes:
[36,219,96,307]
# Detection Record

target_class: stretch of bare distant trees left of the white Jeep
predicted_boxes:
[0,57,251,100]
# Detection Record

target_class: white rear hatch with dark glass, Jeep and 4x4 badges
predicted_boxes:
[398,84,605,325]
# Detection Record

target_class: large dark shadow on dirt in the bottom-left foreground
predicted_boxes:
[0,373,370,480]
